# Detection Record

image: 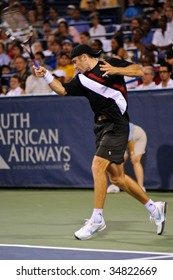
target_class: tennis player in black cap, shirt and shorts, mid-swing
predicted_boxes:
[33,44,167,240]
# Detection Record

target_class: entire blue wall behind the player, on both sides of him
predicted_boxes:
[0,91,173,190]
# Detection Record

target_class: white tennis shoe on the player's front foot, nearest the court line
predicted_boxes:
[74,217,106,240]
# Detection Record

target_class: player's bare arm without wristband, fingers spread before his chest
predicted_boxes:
[100,60,144,77]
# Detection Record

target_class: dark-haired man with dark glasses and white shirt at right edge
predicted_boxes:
[157,62,173,89]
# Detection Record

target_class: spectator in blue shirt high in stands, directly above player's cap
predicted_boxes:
[68,8,90,33]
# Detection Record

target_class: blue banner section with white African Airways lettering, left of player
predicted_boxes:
[0,96,95,187]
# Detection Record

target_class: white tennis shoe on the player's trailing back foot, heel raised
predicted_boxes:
[150,201,167,235]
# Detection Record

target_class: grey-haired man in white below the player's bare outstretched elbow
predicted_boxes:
[135,66,156,90]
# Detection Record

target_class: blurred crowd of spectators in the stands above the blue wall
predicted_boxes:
[0,0,173,97]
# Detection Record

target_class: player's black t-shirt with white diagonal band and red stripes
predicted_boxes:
[64,58,132,121]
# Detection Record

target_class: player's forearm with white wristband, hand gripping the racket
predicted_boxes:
[33,65,67,95]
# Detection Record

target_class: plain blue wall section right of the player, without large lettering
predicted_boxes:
[127,89,173,190]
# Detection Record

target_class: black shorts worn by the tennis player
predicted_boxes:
[94,119,129,164]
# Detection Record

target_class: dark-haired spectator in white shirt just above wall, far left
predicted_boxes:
[6,74,25,96]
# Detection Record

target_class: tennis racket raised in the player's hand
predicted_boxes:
[1,5,39,68]
